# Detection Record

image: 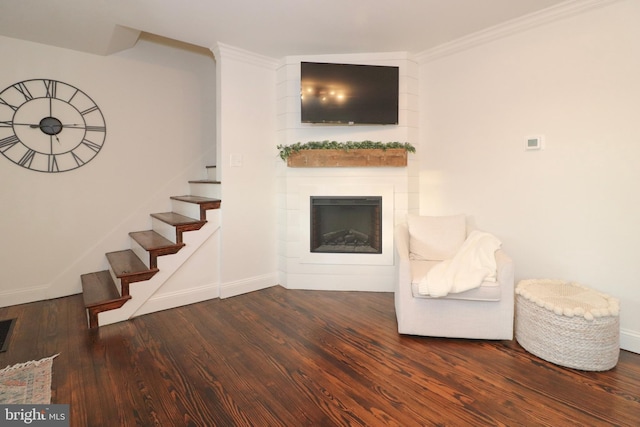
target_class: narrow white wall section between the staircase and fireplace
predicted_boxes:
[213,44,277,298]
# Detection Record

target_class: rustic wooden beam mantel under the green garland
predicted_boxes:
[287,148,407,168]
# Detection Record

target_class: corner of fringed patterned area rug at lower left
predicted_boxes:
[0,354,57,405]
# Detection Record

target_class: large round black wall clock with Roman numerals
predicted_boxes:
[0,79,107,172]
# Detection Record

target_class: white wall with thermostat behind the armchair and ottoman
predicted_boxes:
[419,0,640,352]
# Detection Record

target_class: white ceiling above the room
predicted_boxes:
[0,0,568,58]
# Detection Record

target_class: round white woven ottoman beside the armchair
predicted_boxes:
[515,280,620,371]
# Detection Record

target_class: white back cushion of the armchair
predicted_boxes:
[407,214,467,261]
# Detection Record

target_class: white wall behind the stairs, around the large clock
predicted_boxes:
[0,37,215,306]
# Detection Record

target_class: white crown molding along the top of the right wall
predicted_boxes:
[414,0,621,64]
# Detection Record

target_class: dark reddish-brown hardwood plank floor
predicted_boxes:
[0,287,640,426]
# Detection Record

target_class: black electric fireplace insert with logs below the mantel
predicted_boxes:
[311,196,382,254]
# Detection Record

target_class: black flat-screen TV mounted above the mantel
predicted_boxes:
[300,62,399,125]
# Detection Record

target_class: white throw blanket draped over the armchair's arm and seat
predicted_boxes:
[418,231,502,297]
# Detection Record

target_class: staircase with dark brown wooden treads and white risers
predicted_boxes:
[80,166,221,328]
